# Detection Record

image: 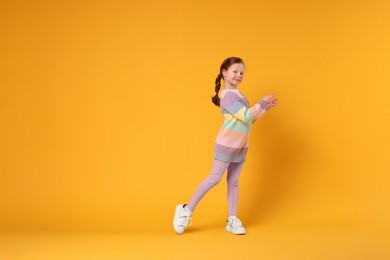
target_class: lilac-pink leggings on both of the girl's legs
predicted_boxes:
[187,160,244,216]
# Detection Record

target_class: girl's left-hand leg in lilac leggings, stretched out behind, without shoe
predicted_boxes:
[187,160,229,211]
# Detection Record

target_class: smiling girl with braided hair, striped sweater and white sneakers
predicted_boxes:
[173,57,277,235]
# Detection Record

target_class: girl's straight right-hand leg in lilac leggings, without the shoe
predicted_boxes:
[226,163,244,216]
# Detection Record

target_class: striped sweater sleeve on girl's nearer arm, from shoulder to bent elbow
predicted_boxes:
[221,92,258,124]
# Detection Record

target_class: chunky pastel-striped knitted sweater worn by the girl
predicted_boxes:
[214,89,271,162]
